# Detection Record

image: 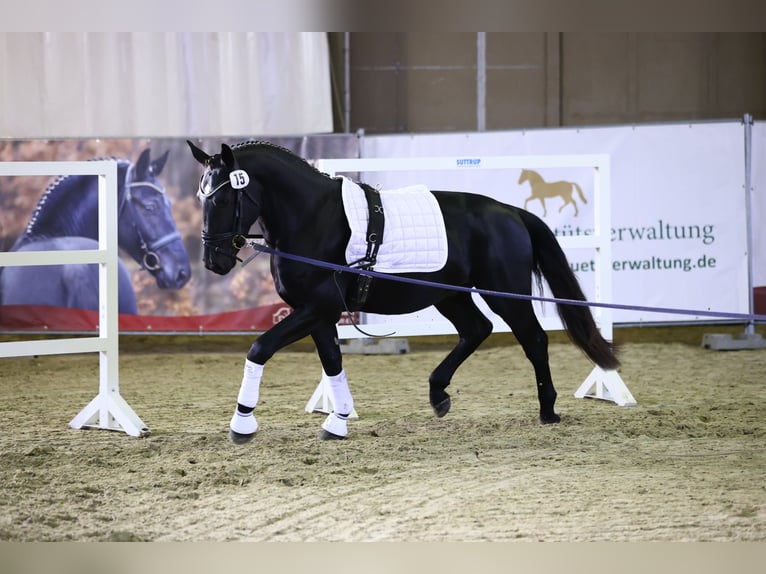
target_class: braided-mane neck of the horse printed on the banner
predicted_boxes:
[16,169,122,247]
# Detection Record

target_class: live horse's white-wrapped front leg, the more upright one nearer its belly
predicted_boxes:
[311,322,354,440]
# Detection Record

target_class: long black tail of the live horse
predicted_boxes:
[519,209,620,369]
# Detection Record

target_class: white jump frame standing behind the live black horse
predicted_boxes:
[305,154,636,413]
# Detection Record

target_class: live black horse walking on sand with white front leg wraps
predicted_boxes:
[187,141,619,442]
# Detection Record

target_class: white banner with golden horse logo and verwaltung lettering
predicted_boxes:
[362,121,749,323]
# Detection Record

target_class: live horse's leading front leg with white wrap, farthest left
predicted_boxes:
[229,307,323,444]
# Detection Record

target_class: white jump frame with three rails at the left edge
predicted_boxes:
[0,161,149,437]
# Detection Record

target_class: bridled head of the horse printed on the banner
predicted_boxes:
[120,149,191,289]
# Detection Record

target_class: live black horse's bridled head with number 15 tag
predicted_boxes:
[186,140,261,275]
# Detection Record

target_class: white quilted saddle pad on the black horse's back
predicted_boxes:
[341,177,447,273]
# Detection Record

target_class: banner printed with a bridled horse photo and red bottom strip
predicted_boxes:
[0,134,359,333]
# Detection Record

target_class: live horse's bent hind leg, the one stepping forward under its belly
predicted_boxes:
[428,293,492,417]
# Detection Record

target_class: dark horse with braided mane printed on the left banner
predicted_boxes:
[0,149,191,314]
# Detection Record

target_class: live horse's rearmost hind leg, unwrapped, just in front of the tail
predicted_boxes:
[485,297,561,424]
